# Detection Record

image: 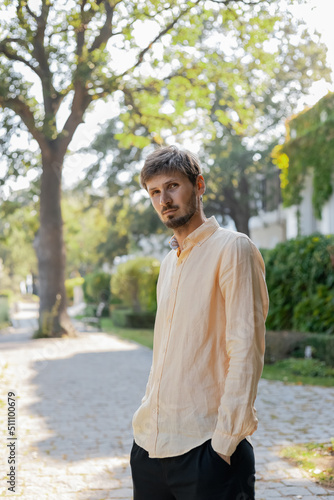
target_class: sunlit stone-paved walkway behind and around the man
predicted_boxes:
[0,304,334,500]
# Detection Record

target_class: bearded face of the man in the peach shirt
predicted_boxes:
[146,172,204,229]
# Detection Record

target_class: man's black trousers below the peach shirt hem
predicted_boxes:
[130,439,255,500]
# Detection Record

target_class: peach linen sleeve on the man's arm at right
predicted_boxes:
[212,236,268,456]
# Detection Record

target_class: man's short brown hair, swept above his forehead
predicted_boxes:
[140,146,202,190]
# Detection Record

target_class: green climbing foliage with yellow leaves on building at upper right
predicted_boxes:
[273,93,334,219]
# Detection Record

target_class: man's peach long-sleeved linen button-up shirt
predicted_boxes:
[132,217,268,458]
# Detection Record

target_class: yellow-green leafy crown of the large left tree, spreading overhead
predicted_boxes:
[0,0,308,175]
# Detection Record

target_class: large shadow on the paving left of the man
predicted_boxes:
[29,349,151,461]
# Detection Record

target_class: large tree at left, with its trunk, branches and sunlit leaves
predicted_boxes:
[0,0,264,336]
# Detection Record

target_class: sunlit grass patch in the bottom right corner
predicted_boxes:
[280,438,334,488]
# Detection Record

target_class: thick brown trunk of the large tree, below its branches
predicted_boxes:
[36,152,76,337]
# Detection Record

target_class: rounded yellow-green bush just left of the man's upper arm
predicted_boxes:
[111,257,160,312]
